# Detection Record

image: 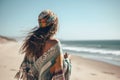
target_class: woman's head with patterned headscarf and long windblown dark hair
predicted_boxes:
[21,10,58,55]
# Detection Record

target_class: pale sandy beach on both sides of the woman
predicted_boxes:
[0,42,120,80]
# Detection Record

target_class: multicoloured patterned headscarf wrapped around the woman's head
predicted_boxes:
[38,10,58,33]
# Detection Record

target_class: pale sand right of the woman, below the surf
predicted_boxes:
[71,55,120,80]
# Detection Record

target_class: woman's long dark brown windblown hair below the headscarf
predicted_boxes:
[20,18,58,57]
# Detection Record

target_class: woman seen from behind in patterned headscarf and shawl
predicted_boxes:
[15,10,71,80]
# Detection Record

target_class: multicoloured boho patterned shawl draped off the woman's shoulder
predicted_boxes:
[15,43,71,80]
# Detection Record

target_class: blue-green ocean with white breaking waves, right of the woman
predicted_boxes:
[61,40,120,66]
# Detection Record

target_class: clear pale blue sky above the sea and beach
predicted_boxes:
[0,0,120,40]
